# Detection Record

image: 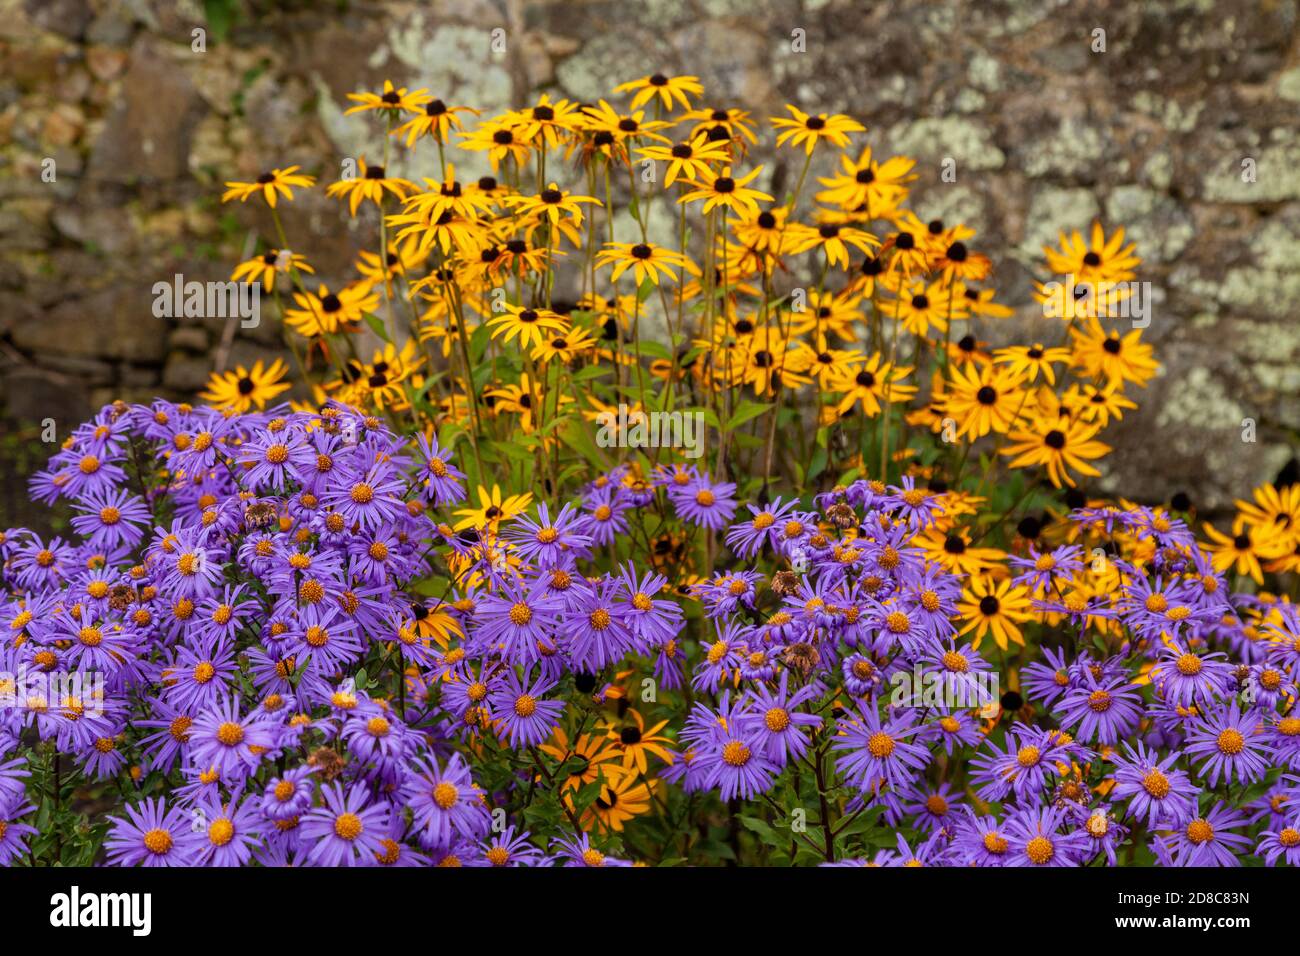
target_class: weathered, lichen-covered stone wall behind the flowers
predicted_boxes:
[0,0,1300,520]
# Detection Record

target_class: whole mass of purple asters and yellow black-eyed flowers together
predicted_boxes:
[0,74,1300,866]
